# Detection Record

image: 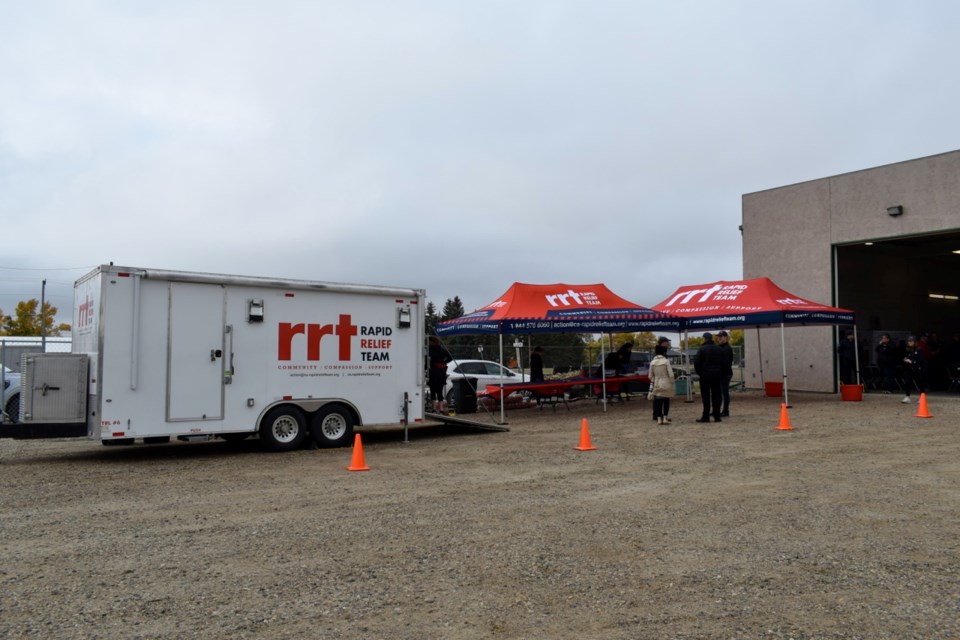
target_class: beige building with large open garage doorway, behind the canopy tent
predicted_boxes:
[742,151,960,392]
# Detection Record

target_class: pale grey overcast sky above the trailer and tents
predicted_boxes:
[0,0,960,321]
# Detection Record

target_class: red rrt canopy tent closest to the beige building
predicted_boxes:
[653,278,860,404]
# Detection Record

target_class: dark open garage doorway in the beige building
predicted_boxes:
[834,231,960,391]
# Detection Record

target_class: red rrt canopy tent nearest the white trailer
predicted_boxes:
[437,282,681,418]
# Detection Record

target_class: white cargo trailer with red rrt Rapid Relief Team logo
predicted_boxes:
[0,265,425,451]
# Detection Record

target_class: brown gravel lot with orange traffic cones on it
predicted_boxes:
[0,392,960,640]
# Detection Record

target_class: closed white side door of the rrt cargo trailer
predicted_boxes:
[167,282,226,422]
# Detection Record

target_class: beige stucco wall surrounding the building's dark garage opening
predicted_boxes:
[742,151,960,392]
